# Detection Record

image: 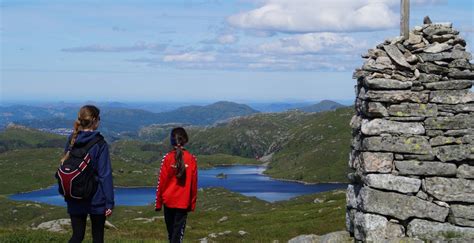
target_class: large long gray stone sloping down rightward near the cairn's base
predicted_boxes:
[357,187,449,222]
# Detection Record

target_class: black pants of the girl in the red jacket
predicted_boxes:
[164,206,188,243]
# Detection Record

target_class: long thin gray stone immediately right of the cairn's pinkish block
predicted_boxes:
[394,160,456,176]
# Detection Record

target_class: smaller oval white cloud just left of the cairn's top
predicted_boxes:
[259,32,367,54]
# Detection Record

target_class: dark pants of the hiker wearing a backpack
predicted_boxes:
[69,214,105,243]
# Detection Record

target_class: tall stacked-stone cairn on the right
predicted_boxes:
[346,19,474,242]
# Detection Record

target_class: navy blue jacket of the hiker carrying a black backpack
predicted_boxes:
[64,131,115,214]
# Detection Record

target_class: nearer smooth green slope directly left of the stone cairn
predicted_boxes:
[265,107,353,182]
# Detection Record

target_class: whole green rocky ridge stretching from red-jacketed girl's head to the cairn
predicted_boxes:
[189,107,353,182]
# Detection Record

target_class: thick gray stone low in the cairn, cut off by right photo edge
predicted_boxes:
[423,177,474,203]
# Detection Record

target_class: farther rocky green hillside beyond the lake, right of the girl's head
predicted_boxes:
[189,111,311,158]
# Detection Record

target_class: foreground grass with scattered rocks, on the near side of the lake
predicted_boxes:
[0,188,345,242]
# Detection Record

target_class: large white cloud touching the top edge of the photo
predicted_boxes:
[228,0,446,32]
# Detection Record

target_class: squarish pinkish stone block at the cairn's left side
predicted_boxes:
[360,152,393,173]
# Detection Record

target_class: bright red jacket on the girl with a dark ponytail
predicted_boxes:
[155,149,198,211]
